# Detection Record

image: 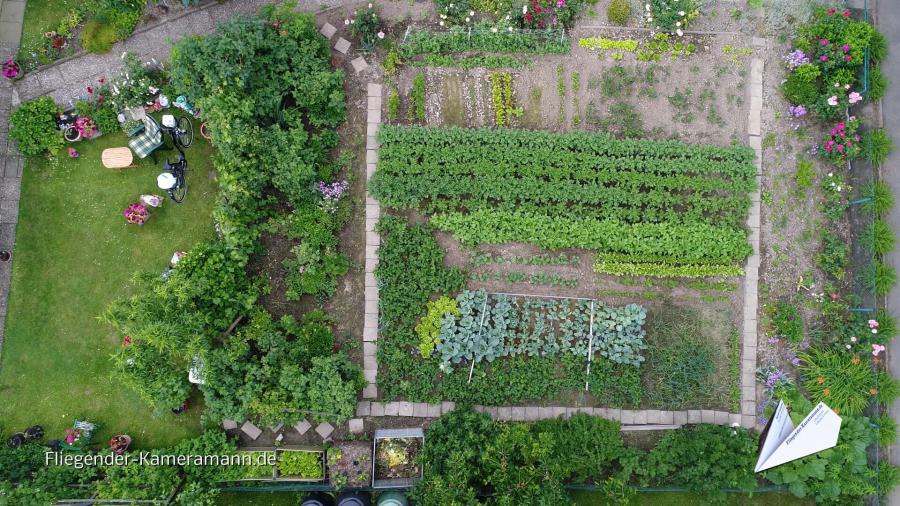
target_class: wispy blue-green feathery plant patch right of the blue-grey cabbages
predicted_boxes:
[643,306,716,409]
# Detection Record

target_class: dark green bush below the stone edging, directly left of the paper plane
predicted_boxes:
[643,425,757,498]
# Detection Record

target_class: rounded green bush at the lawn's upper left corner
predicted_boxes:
[9,97,63,156]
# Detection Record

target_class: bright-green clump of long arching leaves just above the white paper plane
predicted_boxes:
[800,348,879,416]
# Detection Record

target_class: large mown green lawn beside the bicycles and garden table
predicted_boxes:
[0,117,216,448]
